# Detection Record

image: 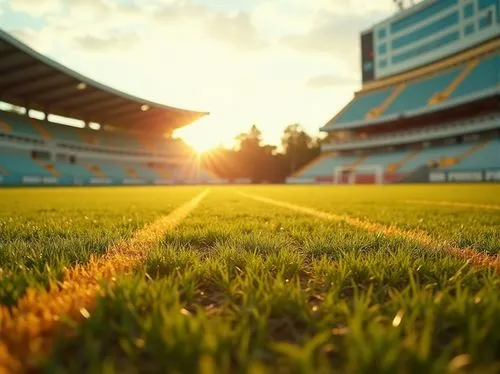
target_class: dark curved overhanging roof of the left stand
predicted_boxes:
[0,30,208,131]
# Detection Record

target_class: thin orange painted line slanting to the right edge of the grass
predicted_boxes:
[236,191,500,271]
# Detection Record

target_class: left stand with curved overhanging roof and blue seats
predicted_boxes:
[0,30,223,185]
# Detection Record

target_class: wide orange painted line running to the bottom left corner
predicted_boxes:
[0,190,209,374]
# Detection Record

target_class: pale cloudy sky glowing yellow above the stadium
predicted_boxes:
[0,0,395,148]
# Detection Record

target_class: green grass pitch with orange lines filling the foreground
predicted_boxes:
[0,185,500,374]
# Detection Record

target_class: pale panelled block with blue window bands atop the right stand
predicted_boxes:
[361,0,500,83]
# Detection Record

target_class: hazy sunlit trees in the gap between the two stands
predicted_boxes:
[202,124,320,183]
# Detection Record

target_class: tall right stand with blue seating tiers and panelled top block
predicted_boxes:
[288,0,500,184]
